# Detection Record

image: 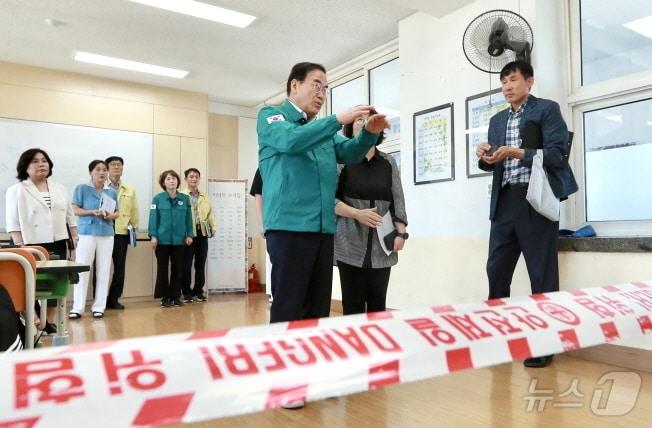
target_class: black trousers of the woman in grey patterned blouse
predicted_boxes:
[337,261,392,315]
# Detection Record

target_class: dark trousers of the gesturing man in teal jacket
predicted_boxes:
[265,230,333,322]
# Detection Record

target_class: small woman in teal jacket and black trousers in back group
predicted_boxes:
[148,169,194,308]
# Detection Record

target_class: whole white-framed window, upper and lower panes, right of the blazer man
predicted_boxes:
[566,0,652,236]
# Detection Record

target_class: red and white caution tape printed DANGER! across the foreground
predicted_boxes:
[0,282,652,427]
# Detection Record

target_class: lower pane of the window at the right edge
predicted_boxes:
[584,98,652,221]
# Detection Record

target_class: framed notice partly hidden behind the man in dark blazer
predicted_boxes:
[465,88,509,178]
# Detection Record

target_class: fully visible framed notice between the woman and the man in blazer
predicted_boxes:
[412,103,455,184]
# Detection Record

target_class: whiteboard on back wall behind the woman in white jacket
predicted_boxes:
[0,118,153,231]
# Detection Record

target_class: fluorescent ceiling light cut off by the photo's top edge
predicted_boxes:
[130,0,256,28]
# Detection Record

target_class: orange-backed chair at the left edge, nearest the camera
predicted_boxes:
[0,248,36,349]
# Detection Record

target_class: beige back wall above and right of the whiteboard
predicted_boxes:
[0,62,208,299]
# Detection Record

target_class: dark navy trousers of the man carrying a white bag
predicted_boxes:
[487,186,559,299]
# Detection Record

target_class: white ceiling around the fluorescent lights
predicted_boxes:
[0,0,473,106]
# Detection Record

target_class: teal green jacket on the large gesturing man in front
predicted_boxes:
[256,100,378,233]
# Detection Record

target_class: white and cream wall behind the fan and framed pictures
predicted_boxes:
[348,0,652,349]
